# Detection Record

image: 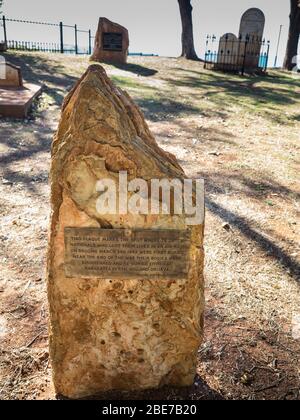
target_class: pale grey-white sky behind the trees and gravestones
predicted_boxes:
[0,0,296,64]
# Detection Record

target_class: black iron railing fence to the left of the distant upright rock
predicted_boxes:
[1,16,94,55]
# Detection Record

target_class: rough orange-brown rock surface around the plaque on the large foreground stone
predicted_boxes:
[48,65,204,398]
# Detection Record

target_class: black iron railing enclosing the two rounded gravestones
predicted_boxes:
[204,34,270,74]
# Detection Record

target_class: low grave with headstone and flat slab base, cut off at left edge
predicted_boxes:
[0,57,42,118]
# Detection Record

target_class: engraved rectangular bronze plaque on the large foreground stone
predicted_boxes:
[65,228,191,279]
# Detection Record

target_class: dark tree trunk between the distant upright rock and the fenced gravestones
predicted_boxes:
[178,0,199,60]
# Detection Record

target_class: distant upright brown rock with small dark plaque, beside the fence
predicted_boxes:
[91,18,129,64]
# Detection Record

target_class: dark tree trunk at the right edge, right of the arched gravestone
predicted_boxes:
[283,0,300,70]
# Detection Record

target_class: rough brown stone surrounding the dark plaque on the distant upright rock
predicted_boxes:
[91,18,129,64]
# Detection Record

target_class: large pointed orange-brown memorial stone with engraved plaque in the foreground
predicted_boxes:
[48,65,204,398]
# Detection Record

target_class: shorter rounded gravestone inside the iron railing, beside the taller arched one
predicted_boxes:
[216,33,240,71]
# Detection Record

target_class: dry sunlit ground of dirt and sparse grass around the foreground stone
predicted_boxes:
[0,53,300,400]
